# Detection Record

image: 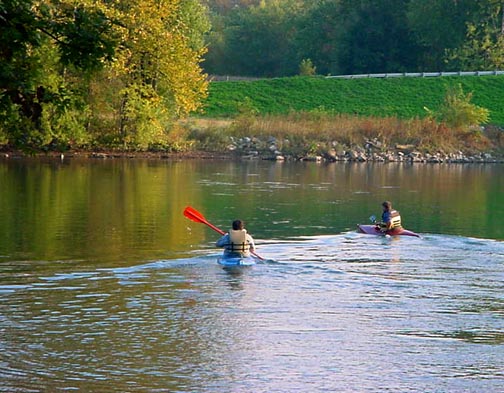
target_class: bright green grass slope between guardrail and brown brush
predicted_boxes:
[204,76,504,125]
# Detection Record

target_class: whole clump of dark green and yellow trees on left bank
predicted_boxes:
[0,0,209,149]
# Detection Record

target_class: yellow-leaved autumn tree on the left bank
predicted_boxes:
[89,0,208,149]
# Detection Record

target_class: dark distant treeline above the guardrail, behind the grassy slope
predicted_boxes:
[203,0,504,77]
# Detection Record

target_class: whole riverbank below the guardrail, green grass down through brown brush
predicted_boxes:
[186,76,504,159]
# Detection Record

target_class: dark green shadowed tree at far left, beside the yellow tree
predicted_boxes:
[0,0,115,149]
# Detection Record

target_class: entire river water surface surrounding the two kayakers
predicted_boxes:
[0,160,504,393]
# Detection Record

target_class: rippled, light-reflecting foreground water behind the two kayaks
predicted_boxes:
[0,232,504,392]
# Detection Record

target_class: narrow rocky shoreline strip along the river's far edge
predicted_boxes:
[0,137,504,164]
